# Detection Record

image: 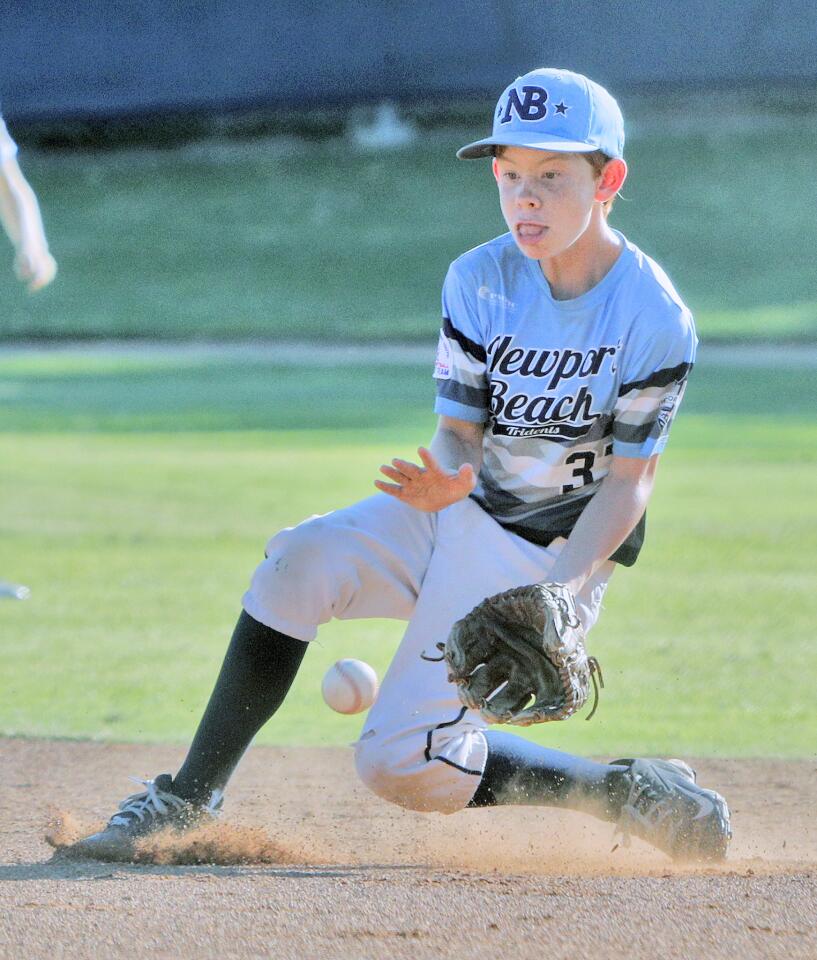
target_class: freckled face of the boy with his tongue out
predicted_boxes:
[493,147,612,260]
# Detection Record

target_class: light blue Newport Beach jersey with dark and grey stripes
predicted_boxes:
[434,234,697,566]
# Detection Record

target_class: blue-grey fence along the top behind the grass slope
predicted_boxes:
[0,0,817,120]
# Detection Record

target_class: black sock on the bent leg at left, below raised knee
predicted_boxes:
[173,610,308,803]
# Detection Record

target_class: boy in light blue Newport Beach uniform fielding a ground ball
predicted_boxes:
[78,69,730,859]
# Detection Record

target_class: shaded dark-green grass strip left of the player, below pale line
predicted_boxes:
[0,361,434,433]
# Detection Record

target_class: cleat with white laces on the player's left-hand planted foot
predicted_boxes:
[68,773,223,860]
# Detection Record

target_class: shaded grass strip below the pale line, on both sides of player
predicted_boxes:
[0,356,817,433]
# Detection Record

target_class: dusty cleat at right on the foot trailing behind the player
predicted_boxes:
[612,760,732,860]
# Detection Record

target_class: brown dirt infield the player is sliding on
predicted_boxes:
[0,740,817,960]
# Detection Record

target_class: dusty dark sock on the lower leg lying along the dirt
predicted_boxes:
[469,730,626,820]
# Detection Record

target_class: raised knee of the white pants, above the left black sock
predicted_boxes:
[250,517,360,624]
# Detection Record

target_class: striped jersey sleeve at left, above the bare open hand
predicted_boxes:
[434,264,490,423]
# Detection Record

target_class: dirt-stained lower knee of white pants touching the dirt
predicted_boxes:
[355,729,487,813]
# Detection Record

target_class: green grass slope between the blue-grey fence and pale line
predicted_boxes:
[0,110,817,340]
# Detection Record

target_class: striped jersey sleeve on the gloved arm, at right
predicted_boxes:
[613,310,698,458]
